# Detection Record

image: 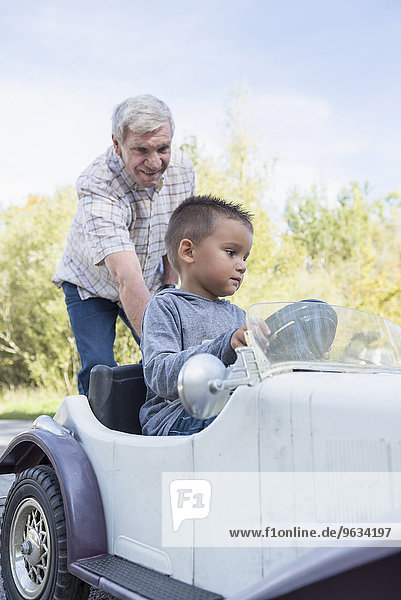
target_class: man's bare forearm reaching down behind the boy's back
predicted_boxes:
[105,250,151,337]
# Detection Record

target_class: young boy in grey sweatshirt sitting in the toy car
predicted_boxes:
[140,196,253,435]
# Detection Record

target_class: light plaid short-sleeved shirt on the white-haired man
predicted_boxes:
[52,146,195,302]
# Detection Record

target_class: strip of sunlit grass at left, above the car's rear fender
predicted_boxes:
[0,388,73,421]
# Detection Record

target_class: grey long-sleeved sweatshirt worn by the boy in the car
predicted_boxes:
[139,289,245,435]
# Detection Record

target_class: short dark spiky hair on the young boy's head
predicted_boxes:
[165,196,253,271]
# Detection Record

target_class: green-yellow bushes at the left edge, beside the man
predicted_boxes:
[0,189,77,386]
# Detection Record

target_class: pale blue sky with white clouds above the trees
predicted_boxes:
[0,0,401,209]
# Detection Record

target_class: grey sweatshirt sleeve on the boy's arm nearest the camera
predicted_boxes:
[141,296,236,401]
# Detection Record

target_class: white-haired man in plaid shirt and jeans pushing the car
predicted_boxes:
[53,95,195,395]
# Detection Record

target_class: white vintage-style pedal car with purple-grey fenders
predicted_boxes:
[0,301,401,600]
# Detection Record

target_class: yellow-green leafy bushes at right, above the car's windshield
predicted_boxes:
[282,183,401,322]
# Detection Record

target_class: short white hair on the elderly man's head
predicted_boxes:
[111,94,174,144]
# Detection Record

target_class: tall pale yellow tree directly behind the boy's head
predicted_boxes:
[182,90,276,308]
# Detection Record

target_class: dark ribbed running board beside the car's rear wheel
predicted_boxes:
[69,554,222,600]
